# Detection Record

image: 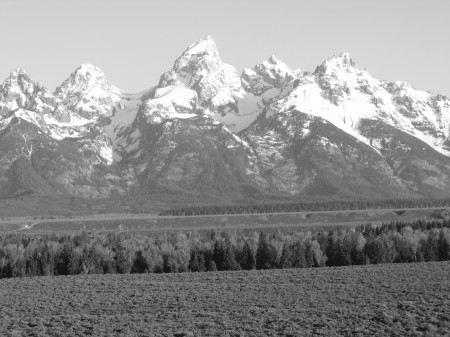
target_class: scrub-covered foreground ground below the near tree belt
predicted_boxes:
[0,262,450,336]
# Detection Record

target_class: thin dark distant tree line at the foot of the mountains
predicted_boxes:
[160,199,450,216]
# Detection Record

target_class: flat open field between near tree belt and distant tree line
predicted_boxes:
[0,208,449,233]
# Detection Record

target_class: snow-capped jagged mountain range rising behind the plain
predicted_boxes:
[0,36,450,212]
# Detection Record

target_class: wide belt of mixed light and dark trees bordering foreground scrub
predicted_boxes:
[0,219,450,278]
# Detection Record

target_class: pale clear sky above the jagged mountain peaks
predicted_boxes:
[0,0,450,97]
